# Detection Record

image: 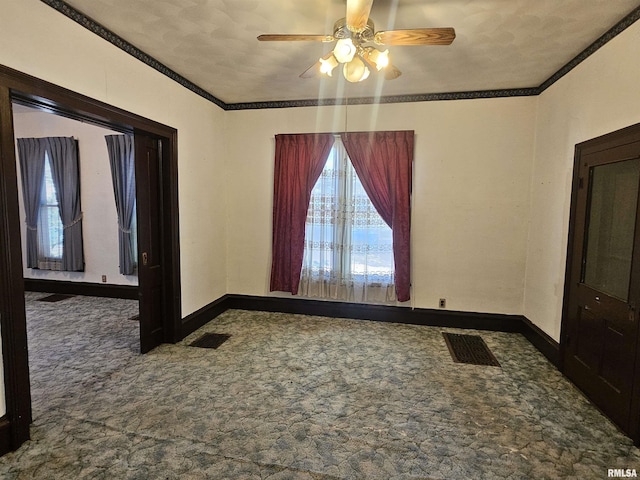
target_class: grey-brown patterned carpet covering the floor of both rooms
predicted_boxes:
[0,293,640,480]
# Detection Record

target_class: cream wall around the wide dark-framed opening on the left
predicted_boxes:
[0,0,227,316]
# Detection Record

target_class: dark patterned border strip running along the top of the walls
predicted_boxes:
[40,0,640,110]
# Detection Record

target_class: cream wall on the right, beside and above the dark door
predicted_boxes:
[524,23,640,340]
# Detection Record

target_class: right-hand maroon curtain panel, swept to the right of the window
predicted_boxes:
[342,130,413,302]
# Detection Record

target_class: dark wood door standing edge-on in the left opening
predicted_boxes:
[135,133,166,353]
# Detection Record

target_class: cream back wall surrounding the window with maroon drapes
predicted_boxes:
[226,97,536,314]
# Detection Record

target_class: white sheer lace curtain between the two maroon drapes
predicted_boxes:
[298,136,396,303]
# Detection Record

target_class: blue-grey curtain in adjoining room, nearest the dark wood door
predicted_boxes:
[105,135,137,275]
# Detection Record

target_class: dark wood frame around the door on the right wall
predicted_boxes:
[559,123,640,446]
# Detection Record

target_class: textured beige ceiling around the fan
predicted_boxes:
[53,0,639,104]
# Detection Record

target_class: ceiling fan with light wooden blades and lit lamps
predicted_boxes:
[258,0,456,82]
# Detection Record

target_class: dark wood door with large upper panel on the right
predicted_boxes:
[562,135,640,434]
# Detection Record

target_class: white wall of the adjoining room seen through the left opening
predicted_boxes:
[13,108,138,285]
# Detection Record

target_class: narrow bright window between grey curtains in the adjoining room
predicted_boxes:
[38,153,63,270]
